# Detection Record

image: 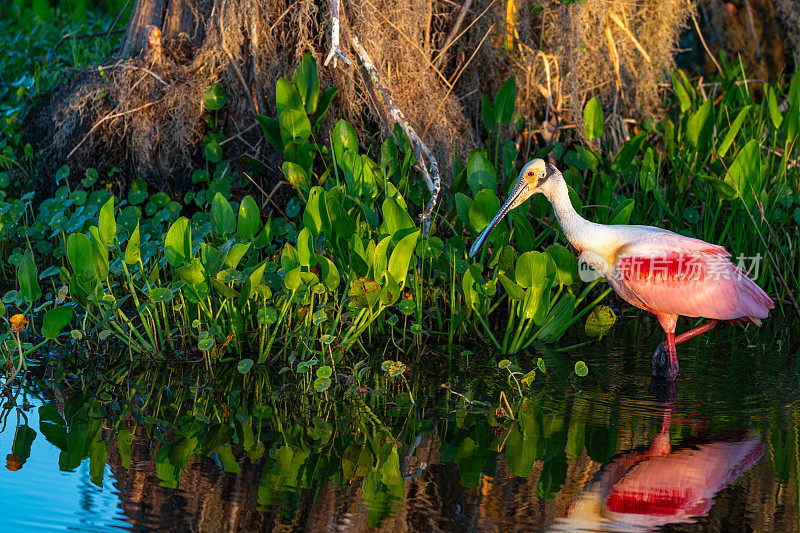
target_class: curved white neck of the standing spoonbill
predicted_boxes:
[542,173,617,254]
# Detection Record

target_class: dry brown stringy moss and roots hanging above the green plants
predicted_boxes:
[48,0,693,188]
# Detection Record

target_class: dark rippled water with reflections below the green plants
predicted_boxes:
[0,318,800,532]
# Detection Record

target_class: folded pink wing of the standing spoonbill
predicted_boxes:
[609,232,773,320]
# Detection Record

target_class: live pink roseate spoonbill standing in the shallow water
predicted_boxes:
[469,159,774,381]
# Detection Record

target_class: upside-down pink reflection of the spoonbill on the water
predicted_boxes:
[549,384,764,531]
